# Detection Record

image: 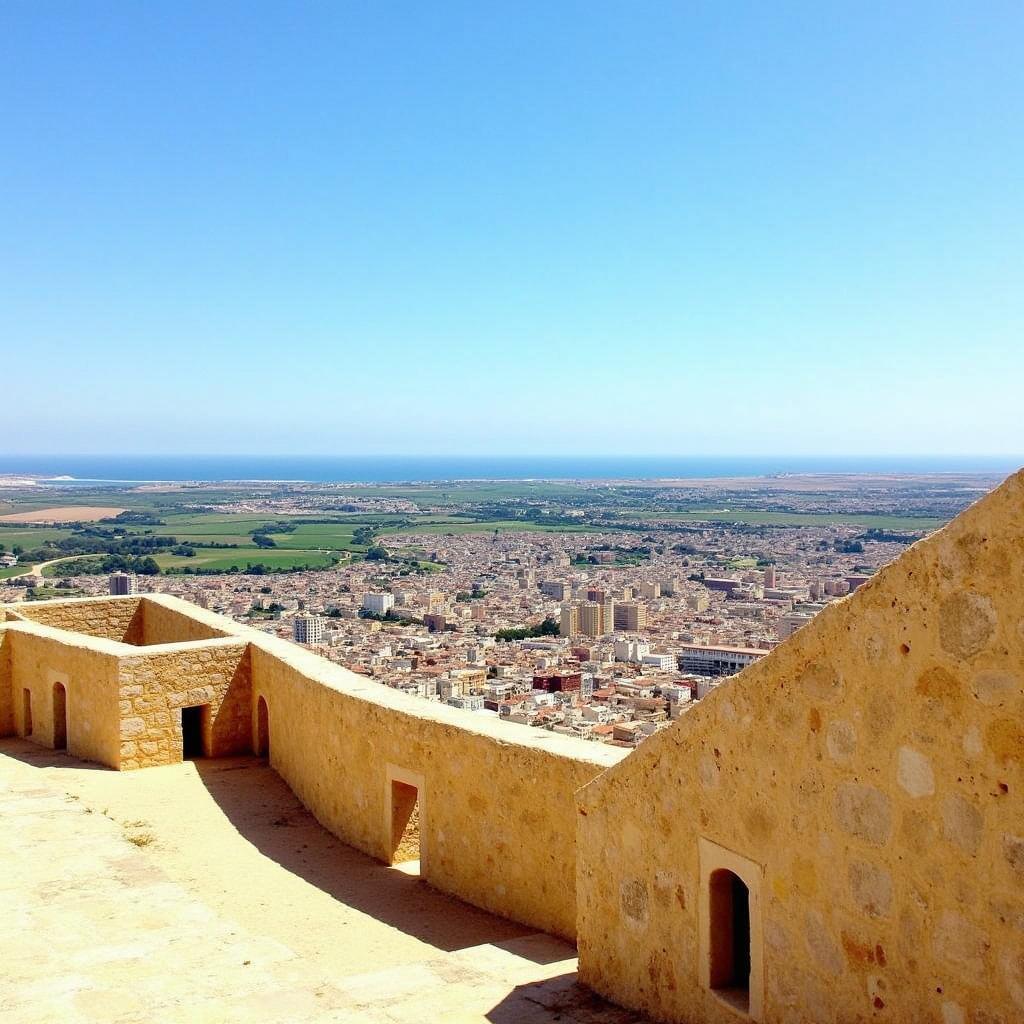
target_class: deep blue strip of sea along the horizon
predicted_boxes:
[0,455,1024,486]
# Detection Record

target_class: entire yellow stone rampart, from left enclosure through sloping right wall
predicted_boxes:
[0,474,1024,1024]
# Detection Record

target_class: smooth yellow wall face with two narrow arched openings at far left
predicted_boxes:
[0,624,120,768]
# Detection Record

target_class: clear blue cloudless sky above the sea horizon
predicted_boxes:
[0,0,1024,455]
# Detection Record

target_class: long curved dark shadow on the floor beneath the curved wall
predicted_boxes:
[191,756,552,957]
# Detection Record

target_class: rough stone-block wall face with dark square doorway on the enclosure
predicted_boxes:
[118,638,252,769]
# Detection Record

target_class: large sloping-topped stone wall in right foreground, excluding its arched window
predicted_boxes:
[578,474,1024,1024]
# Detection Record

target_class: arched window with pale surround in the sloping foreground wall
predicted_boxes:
[698,839,764,1021]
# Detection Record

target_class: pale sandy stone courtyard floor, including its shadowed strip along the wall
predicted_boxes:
[0,739,640,1024]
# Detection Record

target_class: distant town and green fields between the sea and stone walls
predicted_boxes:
[0,468,995,748]
